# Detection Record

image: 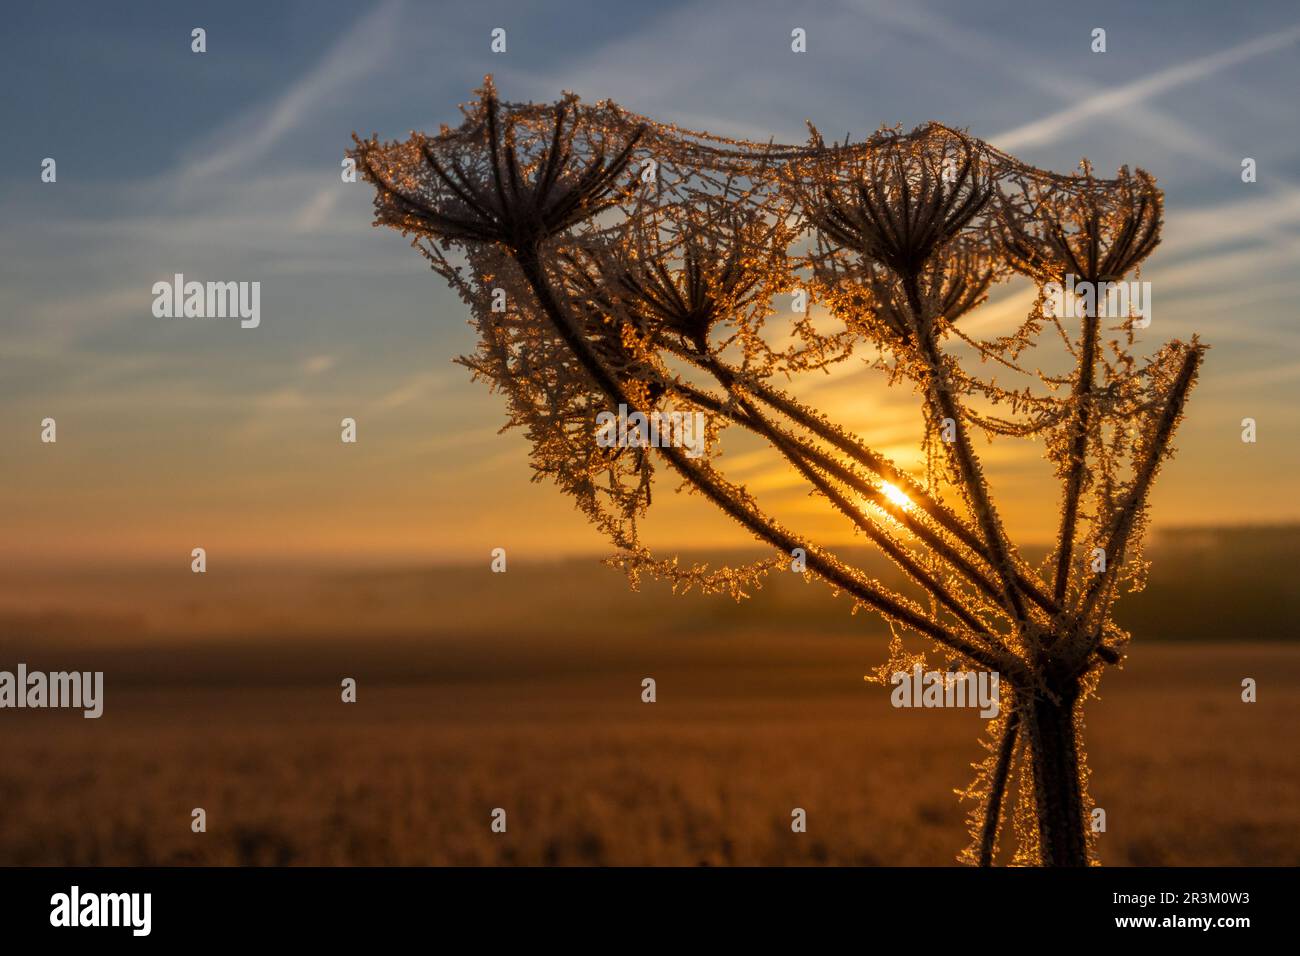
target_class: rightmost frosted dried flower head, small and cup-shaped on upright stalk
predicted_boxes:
[998,166,1165,282]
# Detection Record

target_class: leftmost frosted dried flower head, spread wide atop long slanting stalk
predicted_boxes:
[355,82,641,252]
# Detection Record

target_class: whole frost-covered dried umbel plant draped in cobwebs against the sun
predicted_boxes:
[352,78,1204,865]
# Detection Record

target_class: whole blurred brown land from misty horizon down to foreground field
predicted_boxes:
[0,530,1300,866]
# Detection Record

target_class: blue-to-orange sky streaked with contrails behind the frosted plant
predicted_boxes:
[0,0,1300,563]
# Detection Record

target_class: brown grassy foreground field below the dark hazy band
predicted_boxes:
[0,645,1300,865]
